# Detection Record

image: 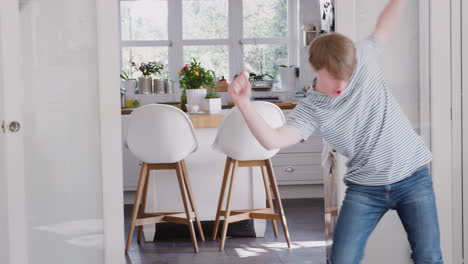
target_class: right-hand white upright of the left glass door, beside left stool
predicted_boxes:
[96,0,126,264]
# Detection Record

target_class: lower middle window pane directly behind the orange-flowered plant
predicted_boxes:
[184,46,229,78]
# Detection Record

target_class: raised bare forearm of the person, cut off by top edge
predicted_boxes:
[373,0,407,44]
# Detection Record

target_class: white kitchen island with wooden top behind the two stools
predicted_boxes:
[122,106,266,241]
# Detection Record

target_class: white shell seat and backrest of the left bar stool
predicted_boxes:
[126,104,198,164]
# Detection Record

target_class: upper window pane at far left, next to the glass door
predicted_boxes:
[120,0,168,40]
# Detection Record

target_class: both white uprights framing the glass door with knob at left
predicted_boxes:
[0,0,125,264]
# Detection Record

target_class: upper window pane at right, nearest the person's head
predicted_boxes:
[242,0,288,38]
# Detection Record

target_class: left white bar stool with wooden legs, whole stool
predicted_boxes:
[125,104,205,254]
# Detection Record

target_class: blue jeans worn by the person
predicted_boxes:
[331,166,443,264]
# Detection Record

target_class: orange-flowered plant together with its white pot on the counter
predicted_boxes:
[179,59,214,109]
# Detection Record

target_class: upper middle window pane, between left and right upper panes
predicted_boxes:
[182,0,228,39]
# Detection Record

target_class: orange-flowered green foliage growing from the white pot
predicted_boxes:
[179,59,215,89]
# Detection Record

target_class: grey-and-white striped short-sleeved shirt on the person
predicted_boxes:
[287,36,431,186]
